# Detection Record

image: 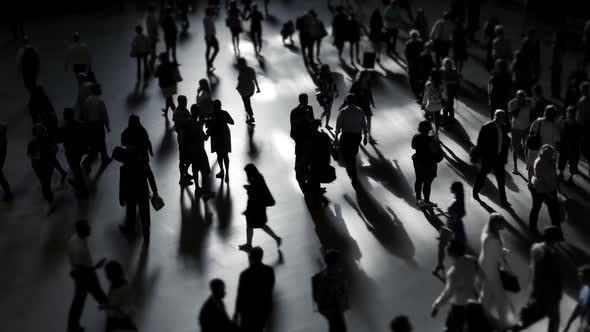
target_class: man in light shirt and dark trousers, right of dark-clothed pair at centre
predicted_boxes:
[336,94,368,184]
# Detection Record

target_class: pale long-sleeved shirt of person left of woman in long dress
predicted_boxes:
[434,256,484,308]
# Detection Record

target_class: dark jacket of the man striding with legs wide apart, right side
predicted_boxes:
[476,121,510,164]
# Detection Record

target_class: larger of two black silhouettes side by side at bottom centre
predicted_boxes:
[234,247,275,332]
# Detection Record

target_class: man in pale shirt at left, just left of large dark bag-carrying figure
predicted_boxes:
[81,83,111,171]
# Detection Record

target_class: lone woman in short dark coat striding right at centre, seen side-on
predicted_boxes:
[239,164,283,251]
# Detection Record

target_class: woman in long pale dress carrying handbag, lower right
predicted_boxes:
[479,213,516,329]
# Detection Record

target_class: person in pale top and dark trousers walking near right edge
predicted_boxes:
[529,144,561,234]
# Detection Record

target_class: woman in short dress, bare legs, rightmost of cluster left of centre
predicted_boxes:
[207,100,234,183]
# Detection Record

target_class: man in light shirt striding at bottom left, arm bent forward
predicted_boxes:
[67,220,108,332]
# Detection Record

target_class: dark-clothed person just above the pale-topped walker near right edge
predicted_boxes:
[558,106,584,184]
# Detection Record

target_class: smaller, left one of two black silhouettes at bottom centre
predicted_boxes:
[199,279,238,332]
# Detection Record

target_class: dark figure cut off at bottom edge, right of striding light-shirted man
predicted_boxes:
[104,261,137,332]
